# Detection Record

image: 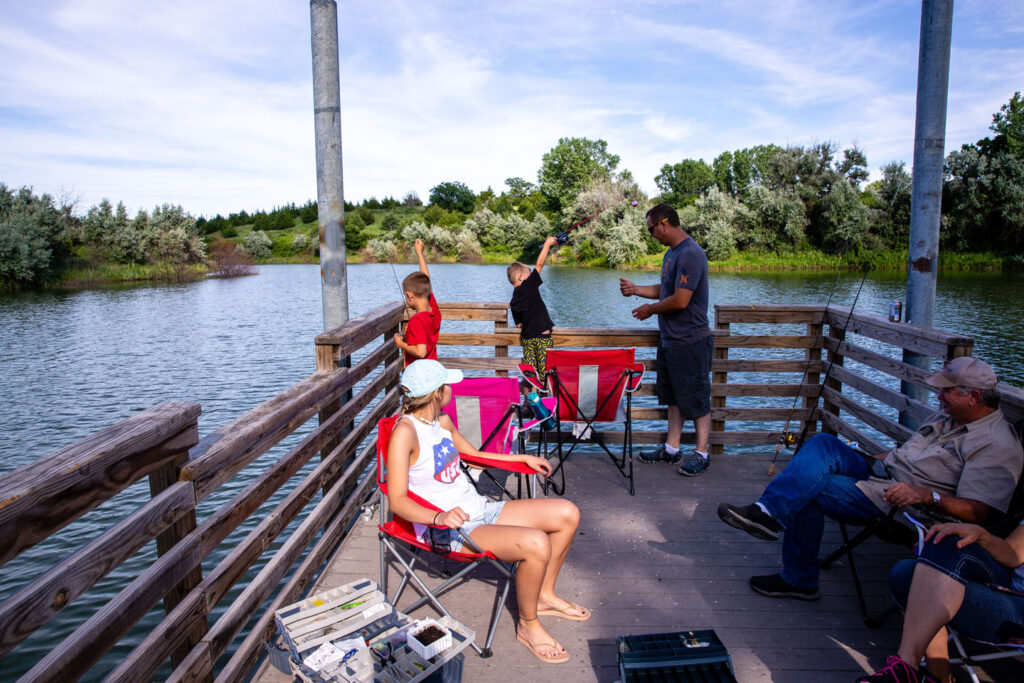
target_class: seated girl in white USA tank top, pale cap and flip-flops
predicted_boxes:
[387,359,591,664]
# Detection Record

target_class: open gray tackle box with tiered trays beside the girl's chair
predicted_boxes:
[274,579,475,683]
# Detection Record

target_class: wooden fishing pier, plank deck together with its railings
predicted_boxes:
[0,302,1024,681]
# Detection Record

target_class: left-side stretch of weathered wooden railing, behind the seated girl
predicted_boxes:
[0,303,403,681]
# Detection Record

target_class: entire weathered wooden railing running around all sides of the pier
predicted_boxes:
[0,303,1024,681]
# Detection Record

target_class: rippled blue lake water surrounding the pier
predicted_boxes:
[0,264,1024,680]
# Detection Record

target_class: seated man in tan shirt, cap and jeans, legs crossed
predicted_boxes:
[718,357,1024,600]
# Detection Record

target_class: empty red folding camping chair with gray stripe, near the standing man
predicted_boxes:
[519,348,643,496]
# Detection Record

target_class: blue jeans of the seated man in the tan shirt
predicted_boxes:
[758,434,883,588]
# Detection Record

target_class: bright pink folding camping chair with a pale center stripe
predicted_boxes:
[441,377,557,498]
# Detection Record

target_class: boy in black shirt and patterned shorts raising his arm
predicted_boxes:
[508,237,558,380]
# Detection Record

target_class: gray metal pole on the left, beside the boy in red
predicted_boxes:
[309,0,348,330]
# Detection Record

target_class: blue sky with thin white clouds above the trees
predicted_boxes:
[0,0,1024,216]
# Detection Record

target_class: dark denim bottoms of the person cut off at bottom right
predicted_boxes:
[889,537,1024,642]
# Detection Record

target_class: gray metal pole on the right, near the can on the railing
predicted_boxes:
[900,0,953,427]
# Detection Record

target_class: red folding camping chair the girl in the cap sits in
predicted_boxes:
[377,416,518,657]
